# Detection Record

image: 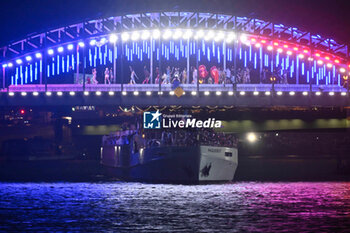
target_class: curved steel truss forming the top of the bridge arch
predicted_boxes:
[0,12,349,61]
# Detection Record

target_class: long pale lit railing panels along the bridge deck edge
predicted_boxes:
[0,84,347,92]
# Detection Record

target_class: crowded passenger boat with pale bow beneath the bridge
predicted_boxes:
[101,129,238,184]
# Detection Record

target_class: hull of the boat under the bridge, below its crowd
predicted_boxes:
[101,146,238,183]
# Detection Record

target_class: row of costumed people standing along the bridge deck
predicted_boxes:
[87,65,328,84]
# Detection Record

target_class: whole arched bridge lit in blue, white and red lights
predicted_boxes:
[0,12,350,107]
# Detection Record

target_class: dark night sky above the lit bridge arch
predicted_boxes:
[0,0,350,46]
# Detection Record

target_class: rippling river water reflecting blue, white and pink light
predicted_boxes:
[0,182,350,232]
